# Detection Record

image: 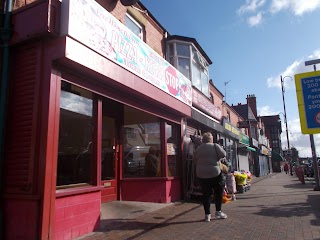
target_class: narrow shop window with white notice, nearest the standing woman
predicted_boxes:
[165,123,180,176]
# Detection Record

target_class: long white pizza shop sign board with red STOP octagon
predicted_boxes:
[61,0,192,106]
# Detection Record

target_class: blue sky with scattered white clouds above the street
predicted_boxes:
[141,0,320,157]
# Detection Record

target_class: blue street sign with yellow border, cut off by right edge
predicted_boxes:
[294,71,320,134]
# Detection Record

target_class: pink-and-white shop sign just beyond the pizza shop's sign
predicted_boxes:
[192,89,222,120]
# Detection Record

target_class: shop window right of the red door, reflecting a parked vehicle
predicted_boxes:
[123,106,162,178]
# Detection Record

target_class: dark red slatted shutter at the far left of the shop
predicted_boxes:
[5,44,41,194]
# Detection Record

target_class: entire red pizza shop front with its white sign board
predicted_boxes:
[3,0,192,240]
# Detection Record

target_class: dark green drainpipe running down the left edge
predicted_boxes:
[0,0,12,239]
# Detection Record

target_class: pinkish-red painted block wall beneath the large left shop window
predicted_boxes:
[54,192,101,240]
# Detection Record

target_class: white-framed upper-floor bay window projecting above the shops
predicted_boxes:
[167,41,210,97]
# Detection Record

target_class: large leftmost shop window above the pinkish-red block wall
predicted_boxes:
[57,82,93,189]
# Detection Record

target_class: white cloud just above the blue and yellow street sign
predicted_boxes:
[267,49,320,88]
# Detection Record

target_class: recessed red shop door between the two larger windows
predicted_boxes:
[101,99,123,203]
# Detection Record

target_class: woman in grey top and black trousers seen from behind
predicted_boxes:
[194,132,227,222]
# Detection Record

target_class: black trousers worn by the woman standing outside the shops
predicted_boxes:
[199,174,224,214]
